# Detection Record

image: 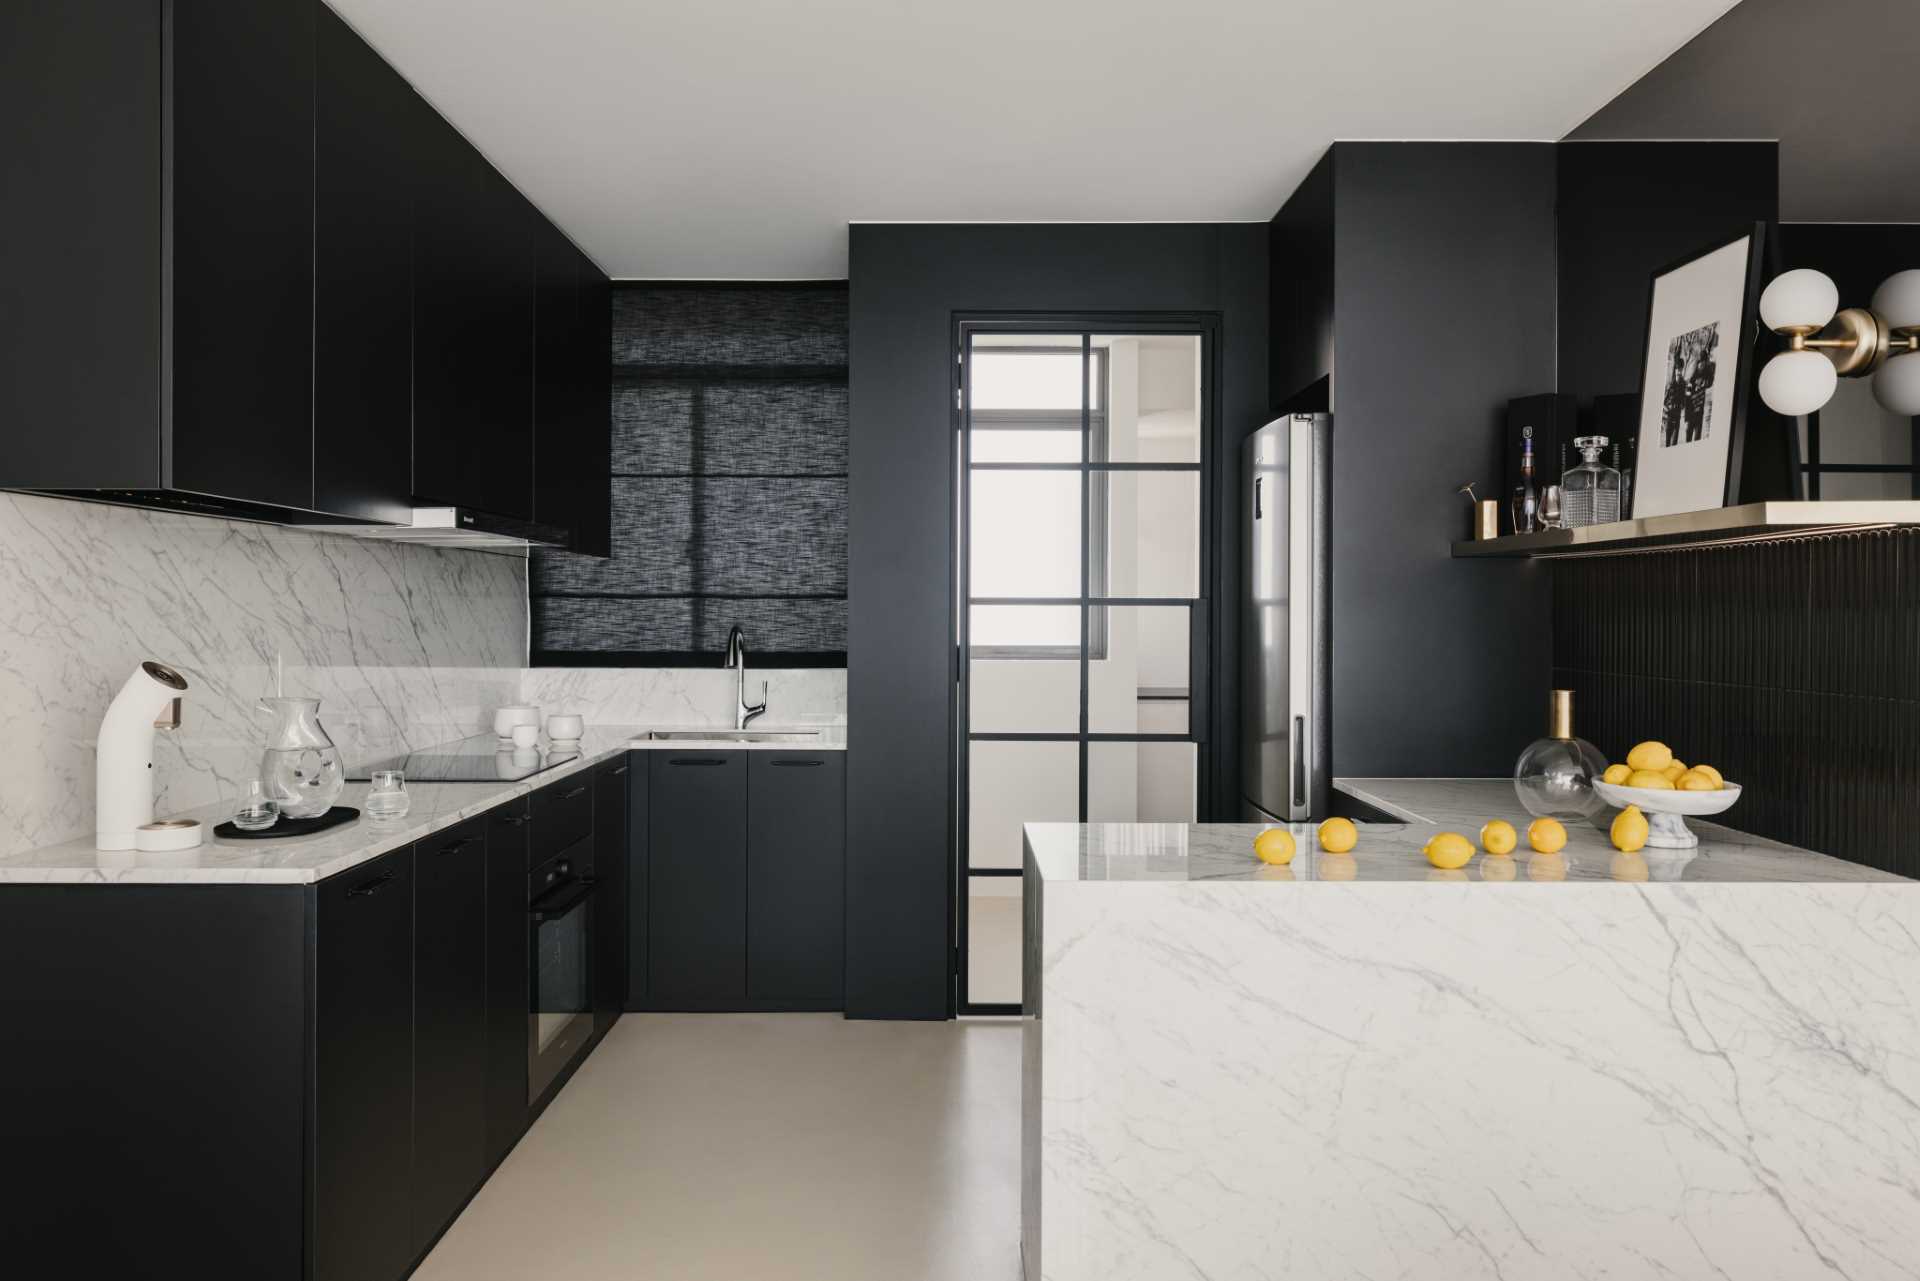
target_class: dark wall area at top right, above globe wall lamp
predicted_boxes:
[1567,0,1920,223]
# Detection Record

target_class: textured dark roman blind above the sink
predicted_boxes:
[530,282,847,666]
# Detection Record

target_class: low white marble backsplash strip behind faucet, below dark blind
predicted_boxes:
[520,668,847,726]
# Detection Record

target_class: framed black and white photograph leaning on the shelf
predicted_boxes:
[1632,223,1764,517]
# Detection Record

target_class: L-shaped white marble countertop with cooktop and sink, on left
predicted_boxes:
[0,724,847,885]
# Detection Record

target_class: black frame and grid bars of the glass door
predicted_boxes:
[947,311,1221,1016]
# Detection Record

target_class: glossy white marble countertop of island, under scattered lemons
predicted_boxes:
[1025,778,1920,885]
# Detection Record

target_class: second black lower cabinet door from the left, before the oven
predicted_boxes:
[413,816,488,1250]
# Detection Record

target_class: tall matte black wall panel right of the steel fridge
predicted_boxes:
[1332,142,1555,776]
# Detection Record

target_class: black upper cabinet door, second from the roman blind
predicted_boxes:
[413,96,538,519]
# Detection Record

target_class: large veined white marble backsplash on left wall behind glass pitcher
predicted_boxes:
[0,494,526,855]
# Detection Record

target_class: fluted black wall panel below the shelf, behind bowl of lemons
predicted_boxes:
[1553,530,1920,876]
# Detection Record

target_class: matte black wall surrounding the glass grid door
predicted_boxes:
[847,223,1267,1018]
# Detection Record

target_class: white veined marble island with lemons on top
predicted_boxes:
[1023,780,1920,1281]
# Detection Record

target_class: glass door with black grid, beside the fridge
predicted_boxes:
[956,323,1210,1014]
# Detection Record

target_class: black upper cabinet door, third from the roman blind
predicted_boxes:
[313,4,413,520]
